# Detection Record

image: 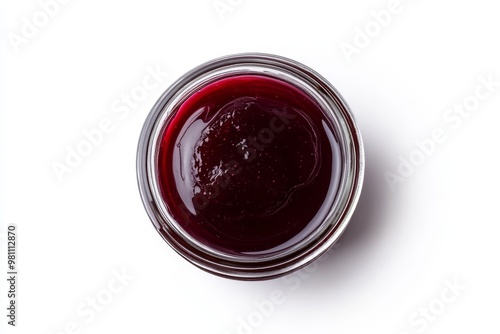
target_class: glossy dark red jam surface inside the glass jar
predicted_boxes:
[157,75,341,256]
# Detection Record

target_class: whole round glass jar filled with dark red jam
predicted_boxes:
[137,53,364,280]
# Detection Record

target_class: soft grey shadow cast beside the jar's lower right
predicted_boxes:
[284,129,392,294]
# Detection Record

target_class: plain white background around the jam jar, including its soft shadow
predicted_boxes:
[0,0,500,334]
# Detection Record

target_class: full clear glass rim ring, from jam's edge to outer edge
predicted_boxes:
[137,53,364,280]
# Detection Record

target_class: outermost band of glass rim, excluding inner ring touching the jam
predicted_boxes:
[137,53,364,280]
